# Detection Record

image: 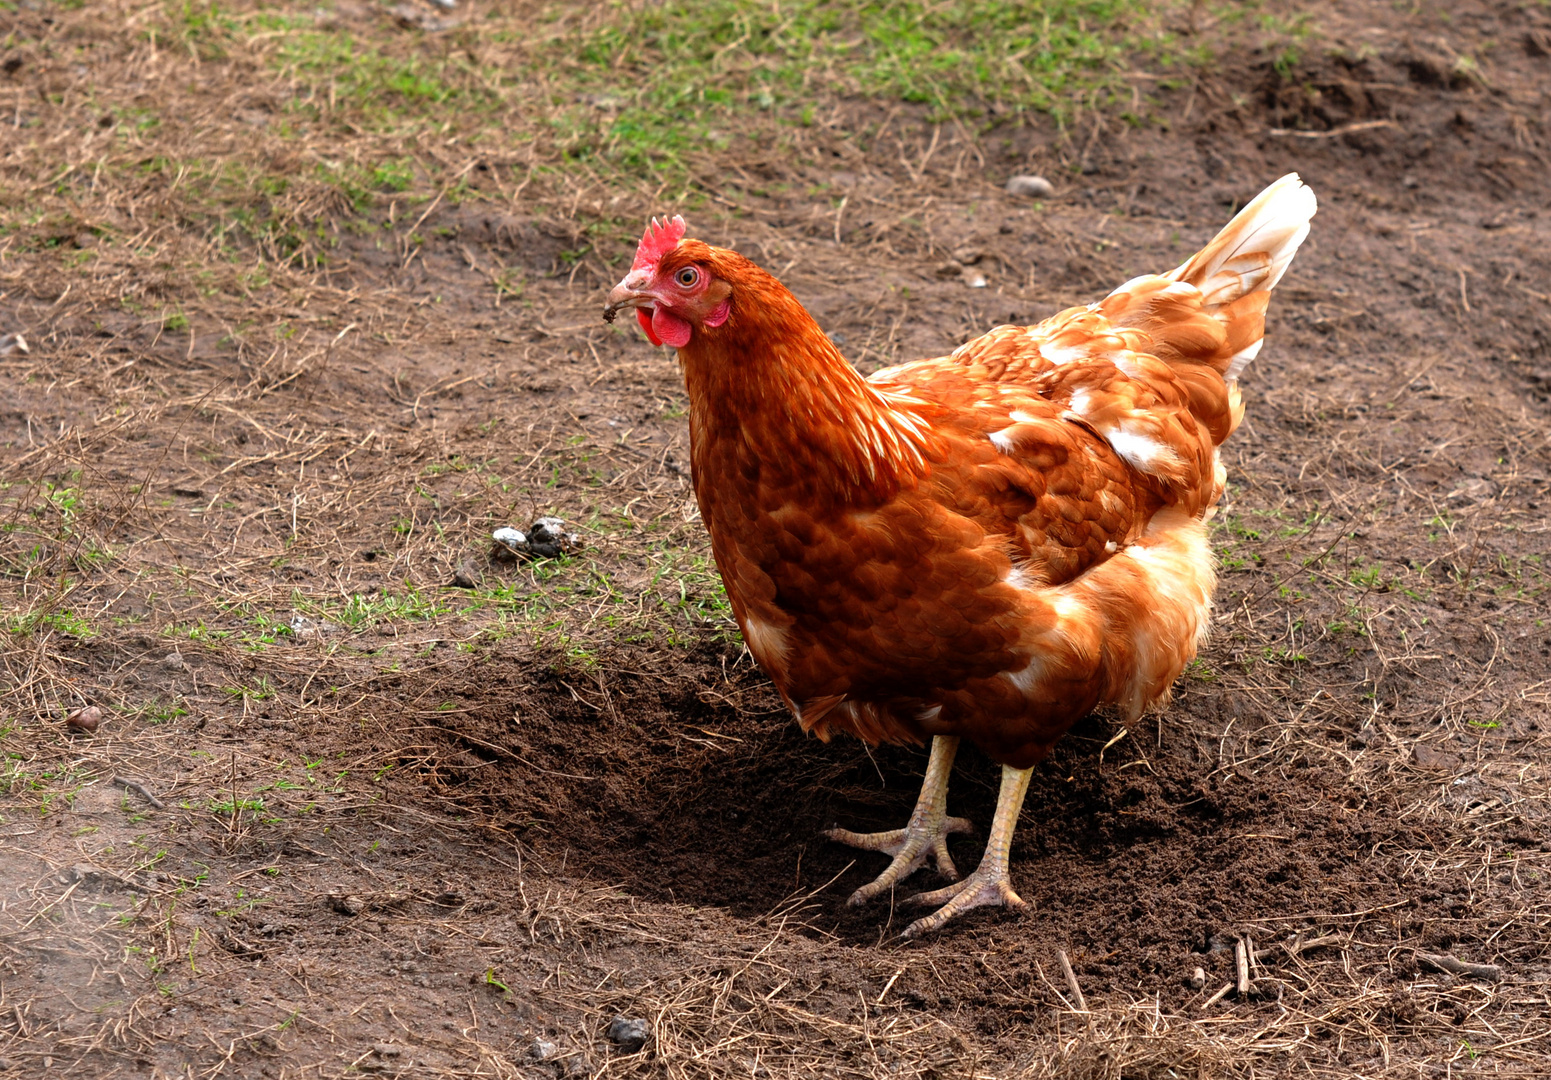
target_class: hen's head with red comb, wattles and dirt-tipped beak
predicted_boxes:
[603,217,737,349]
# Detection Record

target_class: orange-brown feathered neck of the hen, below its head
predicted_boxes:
[679,289,929,504]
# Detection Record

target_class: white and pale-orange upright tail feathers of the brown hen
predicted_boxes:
[1166,172,1318,312]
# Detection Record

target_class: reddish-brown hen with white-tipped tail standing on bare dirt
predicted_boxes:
[603,174,1315,937]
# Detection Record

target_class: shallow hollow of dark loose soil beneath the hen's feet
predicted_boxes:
[378,653,1405,982]
